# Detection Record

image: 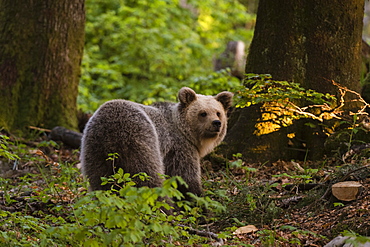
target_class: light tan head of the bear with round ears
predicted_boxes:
[178,87,233,157]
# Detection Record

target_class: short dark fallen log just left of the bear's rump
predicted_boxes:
[49,126,82,148]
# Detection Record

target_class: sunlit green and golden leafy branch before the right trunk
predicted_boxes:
[236,74,341,135]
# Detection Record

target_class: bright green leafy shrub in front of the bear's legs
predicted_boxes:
[46,172,223,246]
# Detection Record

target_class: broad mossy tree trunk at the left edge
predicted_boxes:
[0,0,85,132]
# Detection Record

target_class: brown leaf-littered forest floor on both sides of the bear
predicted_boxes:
[0,131,370,246]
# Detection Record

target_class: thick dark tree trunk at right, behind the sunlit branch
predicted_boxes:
[225,0,364,162]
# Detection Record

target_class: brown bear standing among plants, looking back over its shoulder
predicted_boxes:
[81,87,233,195]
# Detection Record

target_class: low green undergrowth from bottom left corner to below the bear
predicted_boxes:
[0,164,224,246]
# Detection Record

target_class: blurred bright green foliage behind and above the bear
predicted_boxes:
[78,0,254,111]
